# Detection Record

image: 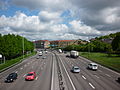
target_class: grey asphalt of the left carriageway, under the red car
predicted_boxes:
[0,54,53,90]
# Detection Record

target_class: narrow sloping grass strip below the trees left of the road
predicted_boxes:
[0,52,36,71]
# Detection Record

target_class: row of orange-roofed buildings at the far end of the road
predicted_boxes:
[34,40,87,48]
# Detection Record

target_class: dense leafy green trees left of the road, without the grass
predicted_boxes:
[0,34,34,60]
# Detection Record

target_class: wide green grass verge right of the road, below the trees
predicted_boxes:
[80,52,120,72]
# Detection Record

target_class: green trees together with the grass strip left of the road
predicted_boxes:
[0,34,35,70]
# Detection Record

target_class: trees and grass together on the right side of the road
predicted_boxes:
[63,32,120,72]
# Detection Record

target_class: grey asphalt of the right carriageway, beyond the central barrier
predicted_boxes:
[57,53,120,90]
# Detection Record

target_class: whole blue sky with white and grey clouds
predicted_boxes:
[0,0,120,41]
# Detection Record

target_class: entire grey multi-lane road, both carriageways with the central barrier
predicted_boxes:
[0,52,120,90]
